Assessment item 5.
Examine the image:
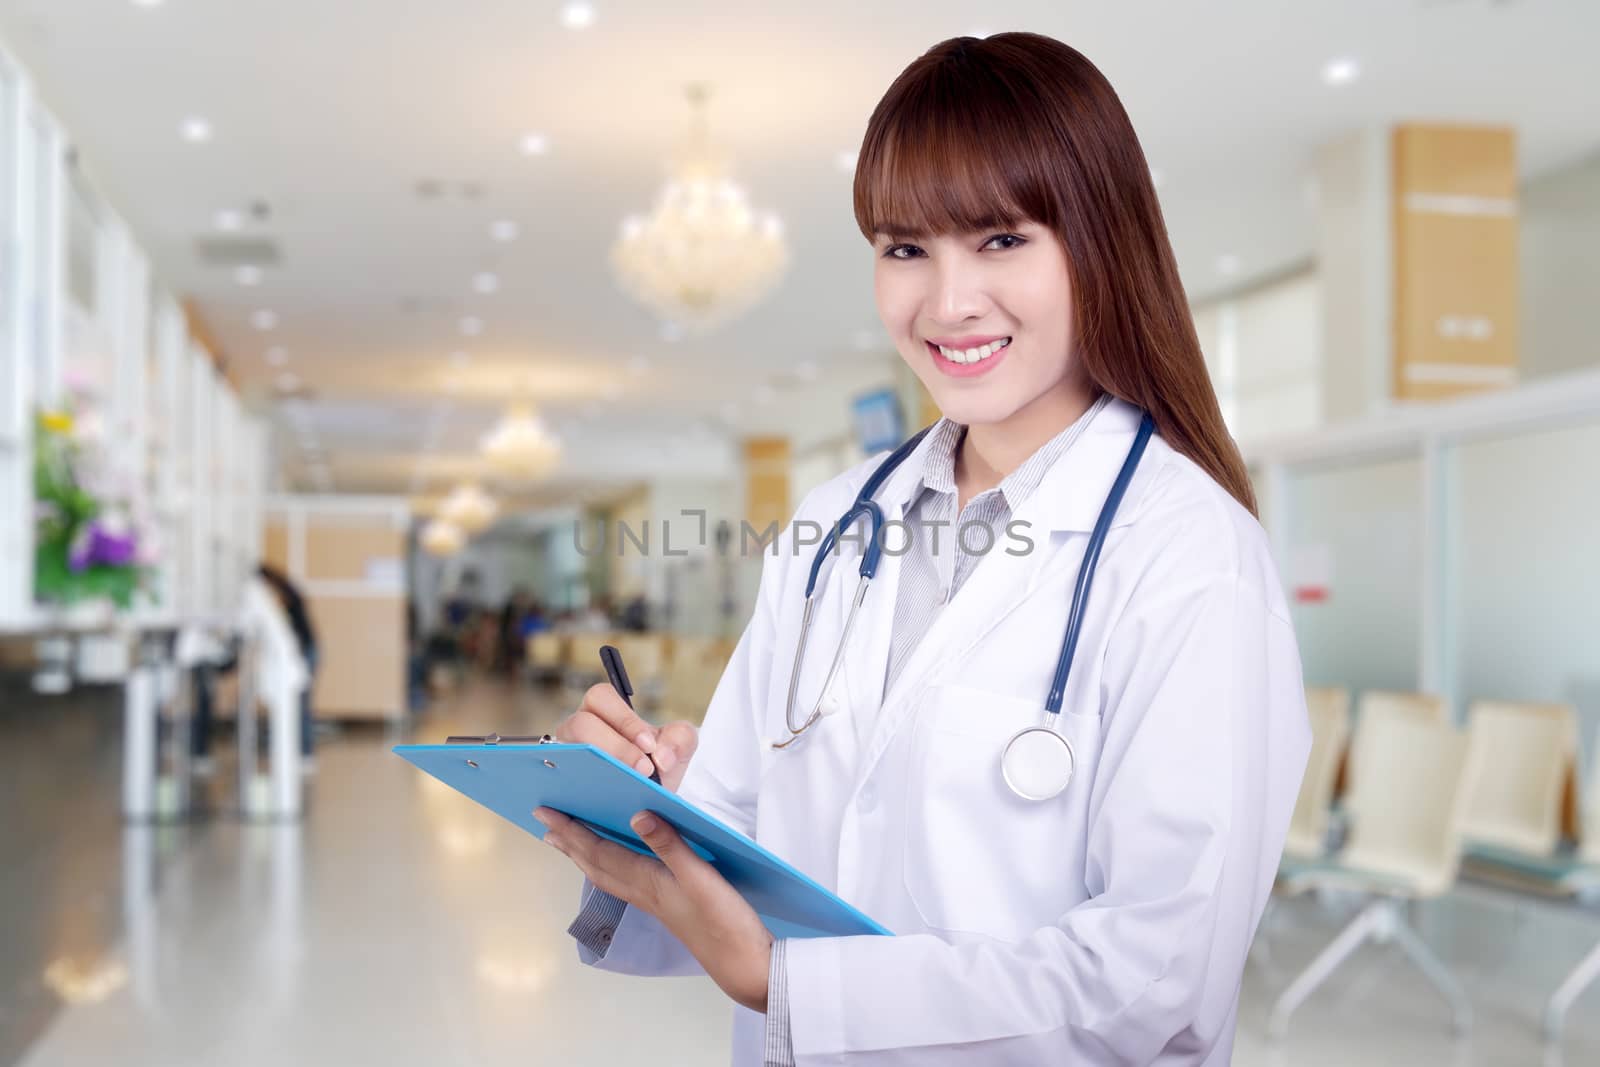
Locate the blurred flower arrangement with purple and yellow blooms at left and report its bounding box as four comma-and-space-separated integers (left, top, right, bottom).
34, 411, 155, 609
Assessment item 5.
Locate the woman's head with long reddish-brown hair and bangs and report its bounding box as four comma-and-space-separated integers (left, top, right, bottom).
854, 34, 1254, 512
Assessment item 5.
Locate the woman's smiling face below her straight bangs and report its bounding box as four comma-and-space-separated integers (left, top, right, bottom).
872, 221, 1075, 426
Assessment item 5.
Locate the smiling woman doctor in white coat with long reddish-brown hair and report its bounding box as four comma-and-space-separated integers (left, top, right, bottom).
538, 34, 1309, 1067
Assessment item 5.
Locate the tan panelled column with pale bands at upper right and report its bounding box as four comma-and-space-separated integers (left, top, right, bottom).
1392, 123, 1518, 400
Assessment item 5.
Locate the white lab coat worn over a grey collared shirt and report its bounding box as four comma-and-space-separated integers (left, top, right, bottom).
598, 402, 1310, 1067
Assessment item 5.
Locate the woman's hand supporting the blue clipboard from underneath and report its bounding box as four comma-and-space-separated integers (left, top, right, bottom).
533, 808, 773, 1013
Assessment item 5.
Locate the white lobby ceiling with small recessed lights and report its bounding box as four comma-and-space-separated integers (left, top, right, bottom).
0, 0, 1600, 491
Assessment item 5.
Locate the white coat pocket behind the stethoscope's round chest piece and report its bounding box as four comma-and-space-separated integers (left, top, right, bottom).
904, 685, 1099, 941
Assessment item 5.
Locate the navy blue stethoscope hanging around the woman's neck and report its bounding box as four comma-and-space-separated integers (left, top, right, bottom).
770, 413, 1155, 800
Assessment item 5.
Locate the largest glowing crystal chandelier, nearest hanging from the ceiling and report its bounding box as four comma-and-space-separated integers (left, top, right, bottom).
611, 83, 789, 331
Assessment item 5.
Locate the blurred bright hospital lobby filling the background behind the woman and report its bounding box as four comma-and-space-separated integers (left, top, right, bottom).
0, 0, 1600, 1067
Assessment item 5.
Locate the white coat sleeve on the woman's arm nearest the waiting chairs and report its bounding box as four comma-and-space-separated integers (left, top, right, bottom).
787, 573, 1309, 1067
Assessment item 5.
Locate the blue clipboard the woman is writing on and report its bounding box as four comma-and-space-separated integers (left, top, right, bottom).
394, 741, 890, 937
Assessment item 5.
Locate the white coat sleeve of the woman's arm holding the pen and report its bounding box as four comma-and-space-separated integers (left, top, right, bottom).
568, 515, 790, 976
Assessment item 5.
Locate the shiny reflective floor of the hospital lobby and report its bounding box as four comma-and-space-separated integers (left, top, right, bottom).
0, 683, 1600, 1067
